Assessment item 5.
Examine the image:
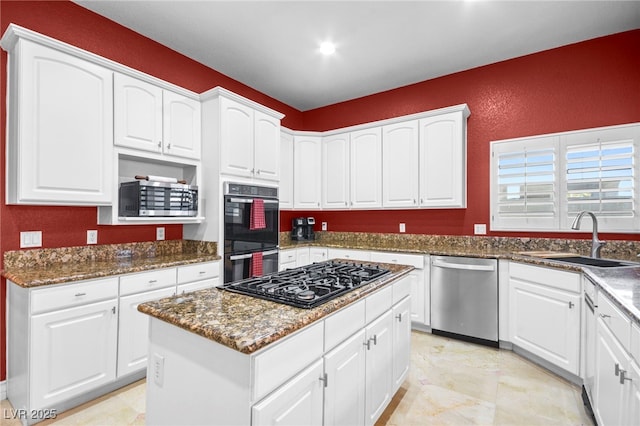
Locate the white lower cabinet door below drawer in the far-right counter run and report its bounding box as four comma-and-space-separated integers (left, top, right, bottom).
593, 317, 637, 425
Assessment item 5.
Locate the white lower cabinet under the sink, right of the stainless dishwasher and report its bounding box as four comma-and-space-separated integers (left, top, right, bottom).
509, 262, 582, 376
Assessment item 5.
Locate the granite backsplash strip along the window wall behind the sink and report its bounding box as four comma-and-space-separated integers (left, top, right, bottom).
280, 231, 640, 261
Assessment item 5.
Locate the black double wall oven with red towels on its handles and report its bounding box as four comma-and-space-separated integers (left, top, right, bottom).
224, 182, 280, 283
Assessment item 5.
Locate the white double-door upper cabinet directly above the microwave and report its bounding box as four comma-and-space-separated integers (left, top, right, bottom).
113, 73, 201, 159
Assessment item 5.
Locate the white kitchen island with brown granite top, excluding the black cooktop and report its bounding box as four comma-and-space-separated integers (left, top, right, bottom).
138, 264, 412, 425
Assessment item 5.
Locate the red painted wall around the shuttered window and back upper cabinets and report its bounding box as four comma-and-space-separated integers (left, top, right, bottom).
281, 30, 640, 243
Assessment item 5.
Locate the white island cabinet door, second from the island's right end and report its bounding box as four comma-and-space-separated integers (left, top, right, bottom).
365, 310, 393, 425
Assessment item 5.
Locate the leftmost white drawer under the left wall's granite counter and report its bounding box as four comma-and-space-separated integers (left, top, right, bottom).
31, 277, 118, 314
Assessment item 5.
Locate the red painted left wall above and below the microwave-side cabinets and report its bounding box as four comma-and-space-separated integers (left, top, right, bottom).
0, 1, 302, 381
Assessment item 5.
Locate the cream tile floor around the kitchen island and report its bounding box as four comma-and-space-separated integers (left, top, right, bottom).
1, 332, 593, 426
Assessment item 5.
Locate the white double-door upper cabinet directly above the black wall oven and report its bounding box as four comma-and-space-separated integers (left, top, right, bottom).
219, 96, 281, 181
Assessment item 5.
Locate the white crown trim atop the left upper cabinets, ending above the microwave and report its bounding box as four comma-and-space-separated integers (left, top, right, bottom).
0, 24, 200, 101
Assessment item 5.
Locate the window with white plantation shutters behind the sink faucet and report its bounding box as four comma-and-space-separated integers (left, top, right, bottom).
491, 125, 640, 232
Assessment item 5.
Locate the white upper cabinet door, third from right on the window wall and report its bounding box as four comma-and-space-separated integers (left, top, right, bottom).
349, 127, 382, 208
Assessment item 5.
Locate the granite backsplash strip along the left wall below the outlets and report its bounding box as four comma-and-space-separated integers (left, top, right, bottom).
4, 240, 218, 269
